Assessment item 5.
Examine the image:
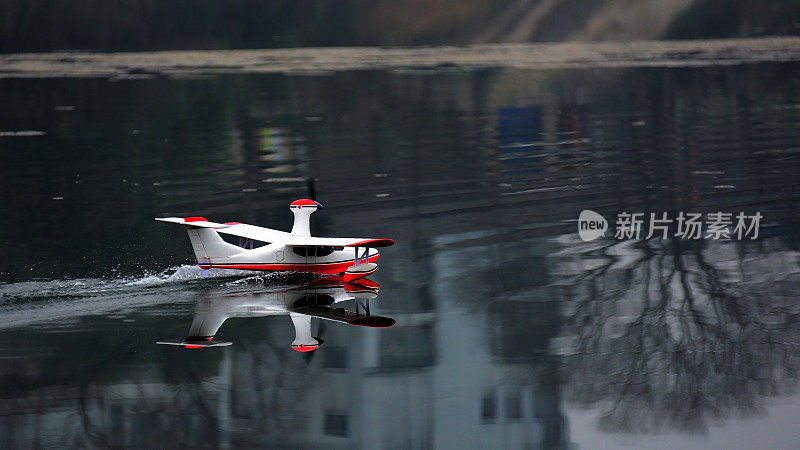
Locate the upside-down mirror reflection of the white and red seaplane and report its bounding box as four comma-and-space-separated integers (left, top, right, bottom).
158, 277, 395, 352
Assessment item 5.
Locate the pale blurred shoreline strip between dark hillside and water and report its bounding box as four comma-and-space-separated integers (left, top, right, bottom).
0, 37, 800, 79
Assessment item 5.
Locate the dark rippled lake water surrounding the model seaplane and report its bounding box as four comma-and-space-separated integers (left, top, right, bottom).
0, 64, 800, 448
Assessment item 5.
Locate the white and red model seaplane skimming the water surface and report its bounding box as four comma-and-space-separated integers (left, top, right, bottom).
156, 199, 394, 282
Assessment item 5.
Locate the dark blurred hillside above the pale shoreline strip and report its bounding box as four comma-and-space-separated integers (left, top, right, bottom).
0, 0, 800, 53
